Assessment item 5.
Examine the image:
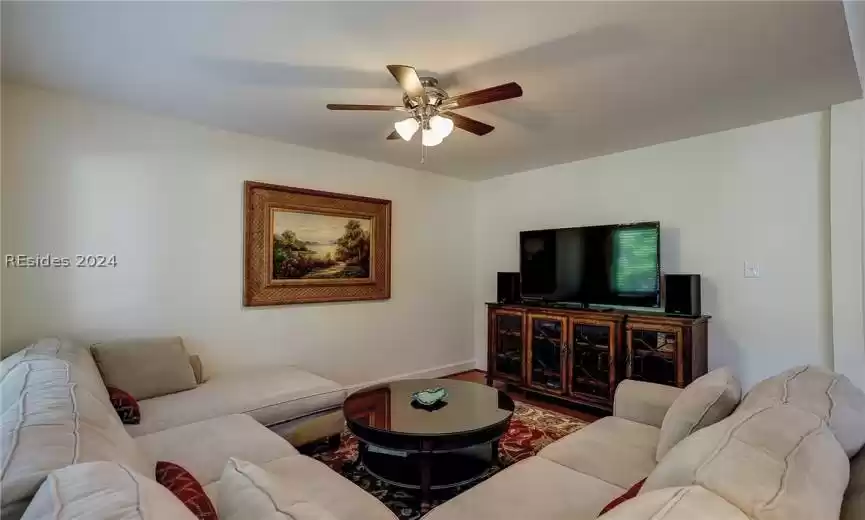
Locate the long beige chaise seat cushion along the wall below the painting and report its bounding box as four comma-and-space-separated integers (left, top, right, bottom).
126, 366, 345, 436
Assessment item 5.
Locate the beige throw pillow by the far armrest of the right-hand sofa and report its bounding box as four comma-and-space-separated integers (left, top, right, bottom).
655, 367, 742, 460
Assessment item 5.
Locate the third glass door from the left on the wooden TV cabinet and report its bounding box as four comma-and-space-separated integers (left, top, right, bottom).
568, 323, 615, 399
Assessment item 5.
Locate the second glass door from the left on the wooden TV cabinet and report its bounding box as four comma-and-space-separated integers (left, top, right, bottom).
529, 316, 567, 393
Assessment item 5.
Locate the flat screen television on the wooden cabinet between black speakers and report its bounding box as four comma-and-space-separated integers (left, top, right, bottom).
520, 222, 661, 307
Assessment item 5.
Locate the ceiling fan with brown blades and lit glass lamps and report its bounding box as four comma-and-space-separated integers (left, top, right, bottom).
327, 65, 523, 147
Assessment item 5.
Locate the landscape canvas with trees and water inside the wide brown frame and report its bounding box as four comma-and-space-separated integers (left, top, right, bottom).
271, 210, 371, 280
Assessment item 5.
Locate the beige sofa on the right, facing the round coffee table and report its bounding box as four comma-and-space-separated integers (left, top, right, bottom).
424, 367, 865, 520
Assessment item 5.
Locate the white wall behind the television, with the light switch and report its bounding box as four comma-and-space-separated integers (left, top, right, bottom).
474, 113, 832, 386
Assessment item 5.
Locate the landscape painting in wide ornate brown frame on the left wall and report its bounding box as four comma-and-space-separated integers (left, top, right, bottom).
243, 181, 391, 306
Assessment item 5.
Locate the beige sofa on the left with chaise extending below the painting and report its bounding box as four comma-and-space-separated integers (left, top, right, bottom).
0, 339, 394, 520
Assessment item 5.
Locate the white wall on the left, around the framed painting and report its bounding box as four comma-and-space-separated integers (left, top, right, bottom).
2, 85, 473, 383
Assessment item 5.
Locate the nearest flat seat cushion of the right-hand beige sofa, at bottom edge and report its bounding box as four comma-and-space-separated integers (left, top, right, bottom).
424, 457, 625, 520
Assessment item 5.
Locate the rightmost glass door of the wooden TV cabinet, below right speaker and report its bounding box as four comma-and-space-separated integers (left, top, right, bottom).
625, 323, 684, 387
